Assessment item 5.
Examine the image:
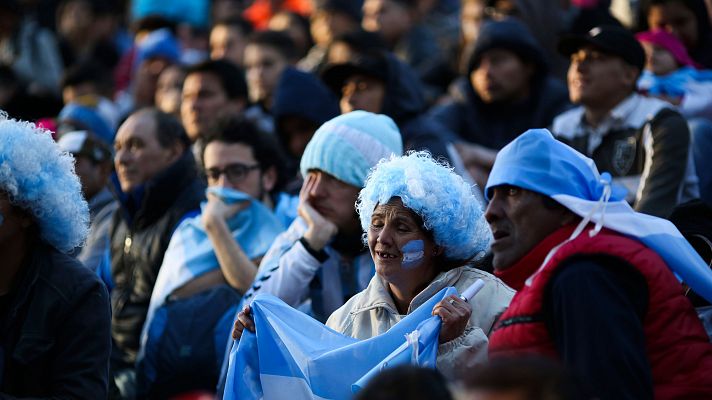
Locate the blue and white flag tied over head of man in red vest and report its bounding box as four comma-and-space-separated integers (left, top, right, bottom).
485, 129, 712, 301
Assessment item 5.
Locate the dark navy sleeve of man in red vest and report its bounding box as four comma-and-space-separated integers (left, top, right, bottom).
544, 257, 653, 400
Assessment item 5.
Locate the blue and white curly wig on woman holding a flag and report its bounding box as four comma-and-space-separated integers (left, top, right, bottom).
356, 151, 491, 261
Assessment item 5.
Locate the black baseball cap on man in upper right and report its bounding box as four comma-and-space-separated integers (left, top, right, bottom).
558, 26, 645, 70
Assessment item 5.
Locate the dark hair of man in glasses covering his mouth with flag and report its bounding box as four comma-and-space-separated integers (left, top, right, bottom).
200, 117, 287, 193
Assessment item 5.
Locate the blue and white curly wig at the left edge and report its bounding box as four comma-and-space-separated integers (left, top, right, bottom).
0, 112, 89, 252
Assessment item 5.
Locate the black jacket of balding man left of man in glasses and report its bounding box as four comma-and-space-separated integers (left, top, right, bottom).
109, 151, 205, 368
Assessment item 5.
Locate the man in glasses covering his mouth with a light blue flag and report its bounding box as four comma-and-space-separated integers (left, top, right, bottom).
137, 119, 286, 398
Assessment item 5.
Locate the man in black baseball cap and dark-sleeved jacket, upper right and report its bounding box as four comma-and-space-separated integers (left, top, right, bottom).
552, 27, 699, 217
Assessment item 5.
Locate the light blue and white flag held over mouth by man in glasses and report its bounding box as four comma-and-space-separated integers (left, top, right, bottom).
142, 187, 284, 358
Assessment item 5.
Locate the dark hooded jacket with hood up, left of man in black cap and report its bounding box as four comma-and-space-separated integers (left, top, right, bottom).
430, 20, 570, 150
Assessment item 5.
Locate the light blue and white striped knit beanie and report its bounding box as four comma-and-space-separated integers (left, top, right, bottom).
300, 111, 403, 188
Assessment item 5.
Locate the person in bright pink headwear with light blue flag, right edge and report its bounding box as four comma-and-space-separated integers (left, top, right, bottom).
635, 30, 712, 119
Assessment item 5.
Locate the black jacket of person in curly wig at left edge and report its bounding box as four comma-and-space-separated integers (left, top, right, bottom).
0, 241, 111, 399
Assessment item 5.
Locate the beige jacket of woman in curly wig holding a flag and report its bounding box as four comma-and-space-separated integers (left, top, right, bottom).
326, 266, 515, 379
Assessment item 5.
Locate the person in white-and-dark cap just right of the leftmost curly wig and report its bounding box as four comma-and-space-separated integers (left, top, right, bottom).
57, 131, 118, 271
